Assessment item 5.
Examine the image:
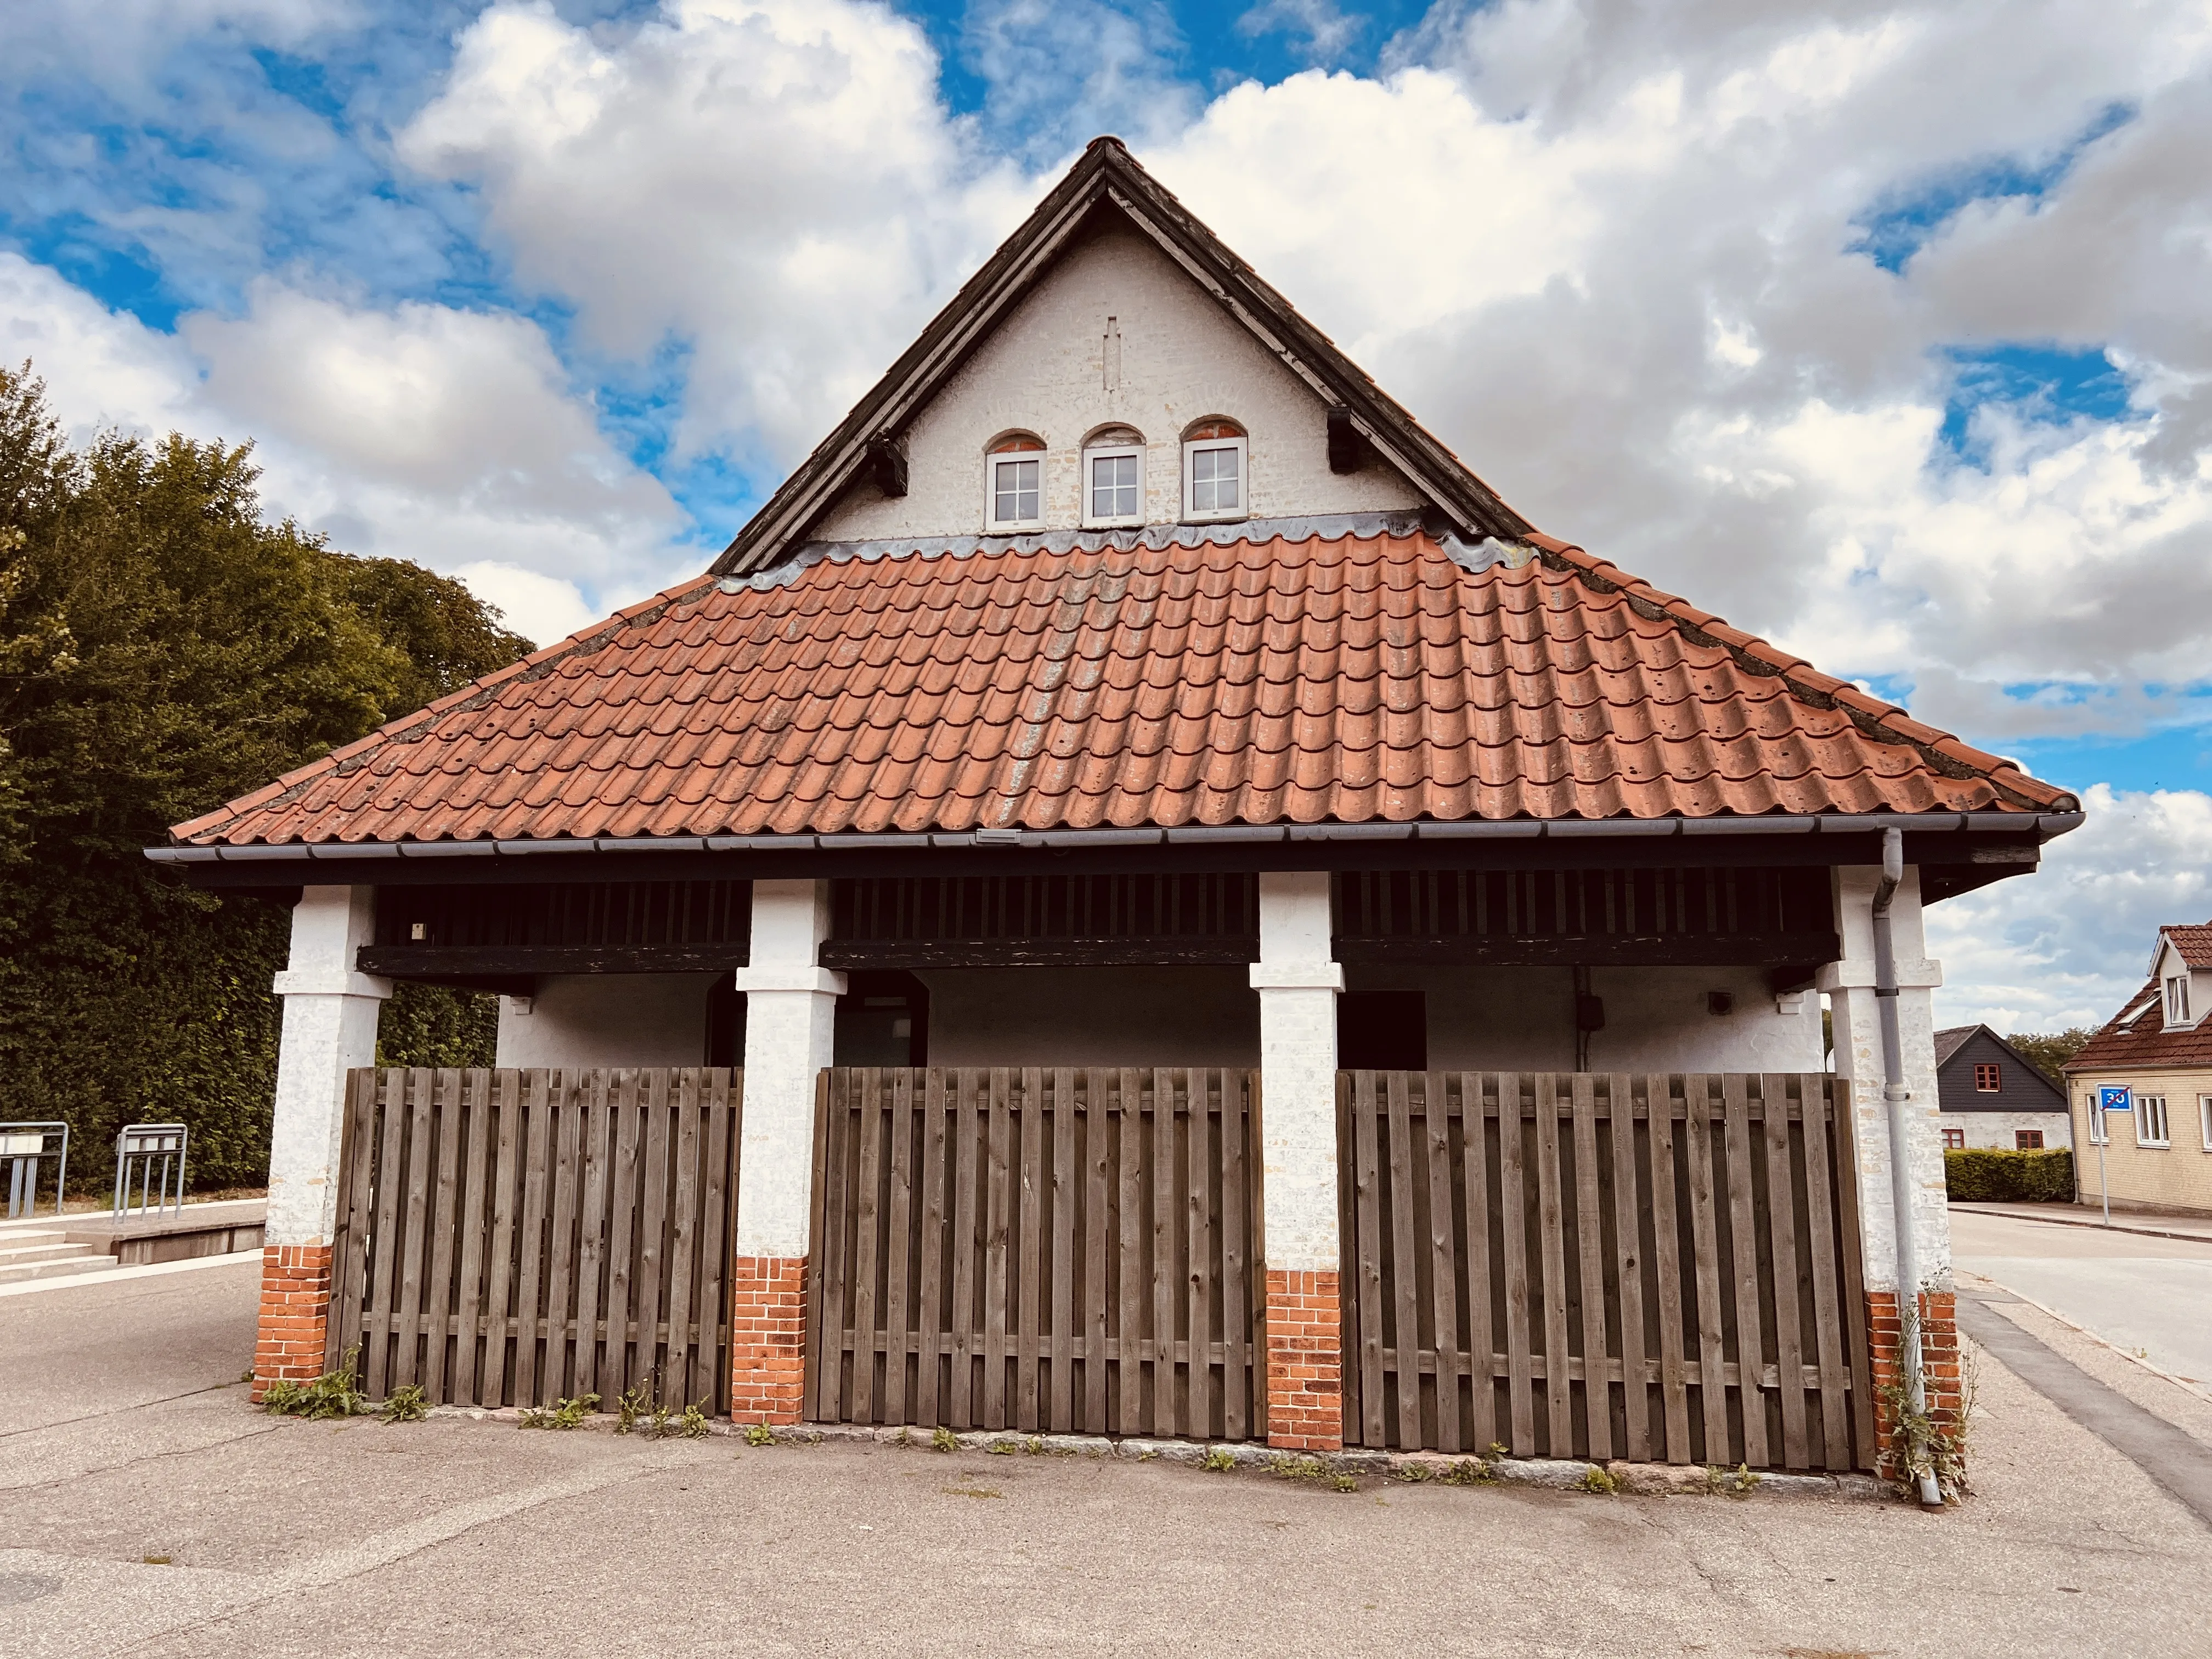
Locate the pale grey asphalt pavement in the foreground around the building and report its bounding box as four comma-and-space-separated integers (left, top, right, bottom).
0, 1265, 2212, 1659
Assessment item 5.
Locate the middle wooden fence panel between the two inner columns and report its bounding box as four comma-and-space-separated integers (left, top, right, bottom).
808, 1068, 1267, 1440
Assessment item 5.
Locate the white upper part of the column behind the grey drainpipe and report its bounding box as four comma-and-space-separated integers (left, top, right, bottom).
1816, 865, 1951, 1292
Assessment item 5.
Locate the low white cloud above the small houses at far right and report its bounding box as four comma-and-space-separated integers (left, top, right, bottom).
1927, 783, 2212, 1031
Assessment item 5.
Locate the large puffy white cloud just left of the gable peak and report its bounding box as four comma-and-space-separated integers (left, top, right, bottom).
396, 0, 1037, 467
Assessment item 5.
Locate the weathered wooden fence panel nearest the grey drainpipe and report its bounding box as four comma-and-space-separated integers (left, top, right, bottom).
1338, 1070, 1874, 1469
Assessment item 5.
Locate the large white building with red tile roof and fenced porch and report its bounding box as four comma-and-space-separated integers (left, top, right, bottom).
150, 139, 2079, 1466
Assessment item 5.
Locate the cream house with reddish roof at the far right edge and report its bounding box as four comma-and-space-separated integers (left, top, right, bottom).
2066, 922, 2212, 1215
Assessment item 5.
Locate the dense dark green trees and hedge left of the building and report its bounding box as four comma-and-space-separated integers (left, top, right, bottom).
0, 365, 529, 1186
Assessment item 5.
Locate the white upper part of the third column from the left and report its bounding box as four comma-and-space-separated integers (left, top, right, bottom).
1252, 872, 1345, 1272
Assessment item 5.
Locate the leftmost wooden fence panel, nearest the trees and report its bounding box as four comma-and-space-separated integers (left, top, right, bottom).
330, 1068, 743, 1411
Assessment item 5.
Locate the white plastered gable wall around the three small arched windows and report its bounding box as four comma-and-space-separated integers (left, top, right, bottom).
814, 230, 1423, 542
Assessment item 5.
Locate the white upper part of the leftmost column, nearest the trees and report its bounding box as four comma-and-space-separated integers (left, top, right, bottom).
268, 887, 392, 1245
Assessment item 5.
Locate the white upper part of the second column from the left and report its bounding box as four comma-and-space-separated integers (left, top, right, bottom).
735, 881, 845, 1259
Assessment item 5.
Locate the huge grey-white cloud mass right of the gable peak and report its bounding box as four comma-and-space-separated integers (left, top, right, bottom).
1146, 0, 2212, 739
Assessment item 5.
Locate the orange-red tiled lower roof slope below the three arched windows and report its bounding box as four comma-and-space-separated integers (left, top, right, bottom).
175, 533, 2075, 845
